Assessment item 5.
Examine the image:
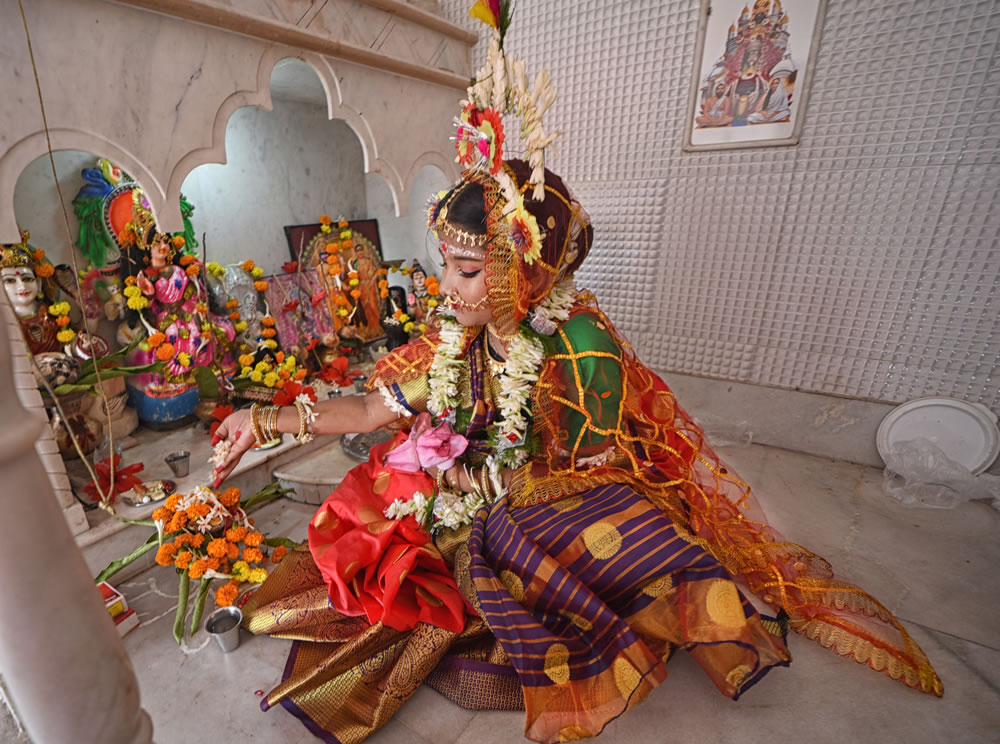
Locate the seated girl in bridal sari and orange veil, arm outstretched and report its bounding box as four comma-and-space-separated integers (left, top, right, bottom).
209, 160, 941, 742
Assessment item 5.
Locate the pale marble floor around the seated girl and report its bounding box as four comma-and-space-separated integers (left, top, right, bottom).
109, 445, 1000, 744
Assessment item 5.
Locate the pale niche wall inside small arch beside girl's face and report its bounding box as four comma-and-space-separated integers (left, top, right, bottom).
365, 165, 450, 264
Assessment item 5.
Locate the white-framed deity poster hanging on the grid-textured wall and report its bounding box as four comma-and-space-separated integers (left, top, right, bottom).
684, 0, 826, 150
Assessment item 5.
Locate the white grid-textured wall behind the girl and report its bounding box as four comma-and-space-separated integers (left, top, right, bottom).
443, 0, 1000, 410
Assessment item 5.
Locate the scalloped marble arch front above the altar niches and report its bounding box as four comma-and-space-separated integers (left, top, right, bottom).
0, 0, 473, 241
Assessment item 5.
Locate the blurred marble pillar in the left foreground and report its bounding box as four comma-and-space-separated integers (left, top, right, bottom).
0, 312, 153, 744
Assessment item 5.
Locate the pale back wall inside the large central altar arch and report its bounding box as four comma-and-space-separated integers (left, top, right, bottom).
181, 100, 368, 273
